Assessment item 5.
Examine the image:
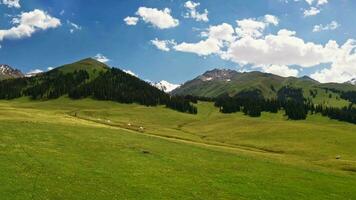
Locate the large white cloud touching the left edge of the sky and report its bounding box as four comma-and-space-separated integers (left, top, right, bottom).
0, 9, 61, 41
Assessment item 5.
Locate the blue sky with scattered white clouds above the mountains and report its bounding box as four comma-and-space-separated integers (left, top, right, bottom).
0, 0, 356, 83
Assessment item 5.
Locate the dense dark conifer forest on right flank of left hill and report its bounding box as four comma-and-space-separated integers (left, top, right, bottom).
69, 68, 197, 114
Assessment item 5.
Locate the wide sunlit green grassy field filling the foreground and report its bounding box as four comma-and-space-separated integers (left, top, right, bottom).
0, 98, 356, 200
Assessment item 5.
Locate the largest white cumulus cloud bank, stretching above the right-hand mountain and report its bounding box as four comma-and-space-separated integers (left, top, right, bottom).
160, 12, 356, 82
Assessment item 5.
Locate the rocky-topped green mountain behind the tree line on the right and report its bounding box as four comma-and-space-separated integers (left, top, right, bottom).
172, 69, 356, 98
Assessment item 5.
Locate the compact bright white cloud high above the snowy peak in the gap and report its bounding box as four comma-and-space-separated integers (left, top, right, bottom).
136, 7, 179, 29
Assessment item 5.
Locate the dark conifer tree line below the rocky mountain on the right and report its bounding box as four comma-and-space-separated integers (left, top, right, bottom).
215, 86, 356, 124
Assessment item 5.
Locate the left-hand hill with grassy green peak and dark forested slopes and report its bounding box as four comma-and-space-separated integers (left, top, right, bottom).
0, 58, 197, 114
